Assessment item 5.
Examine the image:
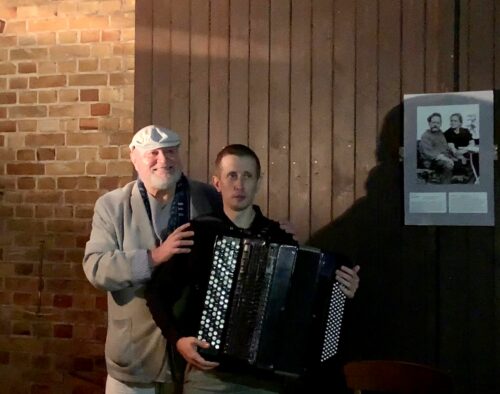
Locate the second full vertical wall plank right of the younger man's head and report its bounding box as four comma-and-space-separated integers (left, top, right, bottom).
290, 0, 311, 241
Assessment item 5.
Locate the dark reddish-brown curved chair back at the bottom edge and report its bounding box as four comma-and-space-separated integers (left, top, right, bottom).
344, 360, 452, 394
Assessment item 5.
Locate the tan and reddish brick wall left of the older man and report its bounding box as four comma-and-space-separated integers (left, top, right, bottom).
0, 0, 135, 394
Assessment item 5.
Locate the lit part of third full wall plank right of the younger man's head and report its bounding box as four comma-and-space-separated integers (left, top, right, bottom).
310, 0, 333, 232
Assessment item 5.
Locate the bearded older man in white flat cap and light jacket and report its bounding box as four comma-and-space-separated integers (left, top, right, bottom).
83, 126, 221, 394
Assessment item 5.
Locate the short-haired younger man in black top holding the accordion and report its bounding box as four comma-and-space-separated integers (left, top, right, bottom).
146, 144, 359, 393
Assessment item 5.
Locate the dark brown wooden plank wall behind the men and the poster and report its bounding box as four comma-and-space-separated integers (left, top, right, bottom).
135, 0, 500, 394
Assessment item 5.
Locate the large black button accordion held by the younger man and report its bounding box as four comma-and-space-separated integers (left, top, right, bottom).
198, 236, 345, 376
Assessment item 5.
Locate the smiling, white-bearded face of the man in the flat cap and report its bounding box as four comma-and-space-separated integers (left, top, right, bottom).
130, 147, 182, 194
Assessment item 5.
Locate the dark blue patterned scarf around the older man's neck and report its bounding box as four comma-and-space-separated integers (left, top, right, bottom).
137, 174, 190, 244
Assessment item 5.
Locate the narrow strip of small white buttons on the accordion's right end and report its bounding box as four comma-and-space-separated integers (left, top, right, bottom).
321, 282, 345, 362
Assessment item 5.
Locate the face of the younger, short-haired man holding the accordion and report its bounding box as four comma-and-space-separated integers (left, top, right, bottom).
212, 155, 260, 212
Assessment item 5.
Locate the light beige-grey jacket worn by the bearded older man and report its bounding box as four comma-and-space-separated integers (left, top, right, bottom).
83, 181, 220, 383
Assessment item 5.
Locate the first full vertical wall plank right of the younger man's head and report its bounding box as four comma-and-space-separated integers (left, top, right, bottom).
268, 0, 290, 219
